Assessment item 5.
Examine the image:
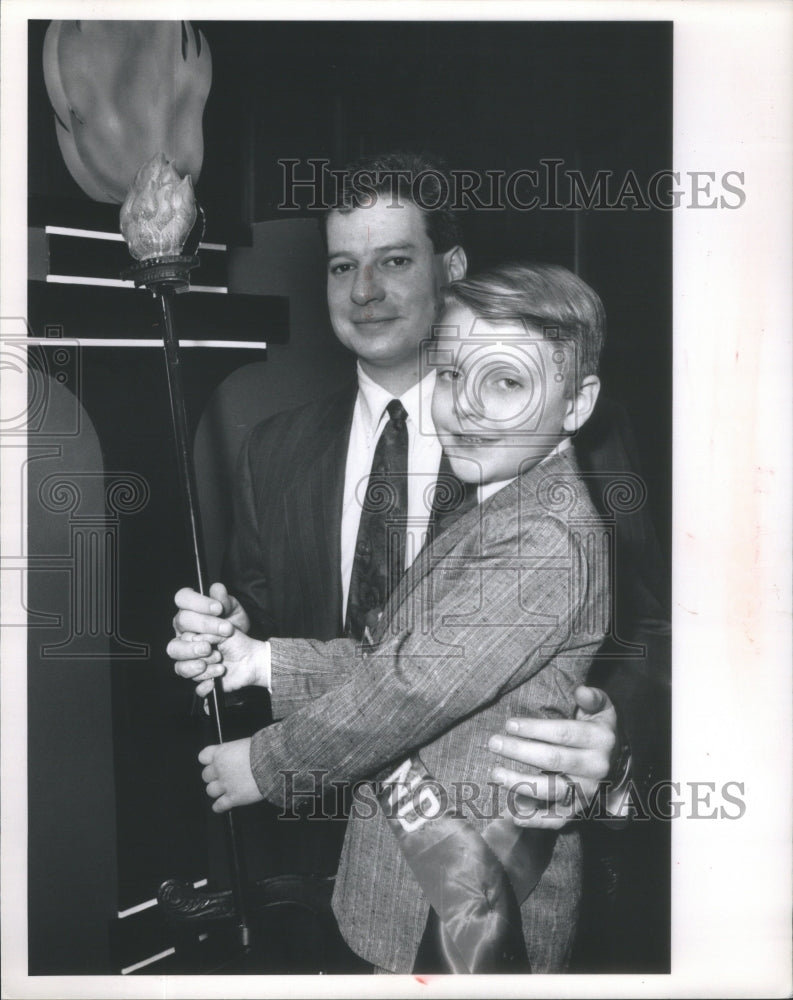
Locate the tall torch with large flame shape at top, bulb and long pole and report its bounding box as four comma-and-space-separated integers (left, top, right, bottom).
42, 19, 255, 950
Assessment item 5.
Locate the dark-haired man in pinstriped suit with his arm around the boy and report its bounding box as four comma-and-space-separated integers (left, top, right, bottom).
168, 155, 664, 968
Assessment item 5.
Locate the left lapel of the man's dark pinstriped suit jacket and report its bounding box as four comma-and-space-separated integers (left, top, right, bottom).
283, 387, 357, 635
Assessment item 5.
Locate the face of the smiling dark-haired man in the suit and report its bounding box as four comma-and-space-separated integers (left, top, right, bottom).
327, 197, 449, 381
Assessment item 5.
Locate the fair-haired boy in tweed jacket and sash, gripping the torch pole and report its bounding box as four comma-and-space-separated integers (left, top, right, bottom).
178, 264, 609, 972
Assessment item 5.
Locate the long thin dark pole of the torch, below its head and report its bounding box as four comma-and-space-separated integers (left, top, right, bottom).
155, 287, 250, 948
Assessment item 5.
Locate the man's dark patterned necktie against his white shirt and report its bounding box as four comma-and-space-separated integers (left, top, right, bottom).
345, 399, 408, 639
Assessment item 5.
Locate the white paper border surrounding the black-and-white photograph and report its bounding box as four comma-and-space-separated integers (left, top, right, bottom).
0, 0, 793, 998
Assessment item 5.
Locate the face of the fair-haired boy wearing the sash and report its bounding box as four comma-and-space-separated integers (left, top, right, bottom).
432, 305, 575, 483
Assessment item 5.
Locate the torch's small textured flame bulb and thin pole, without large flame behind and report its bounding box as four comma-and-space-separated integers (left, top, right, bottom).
121, 153, 250, 948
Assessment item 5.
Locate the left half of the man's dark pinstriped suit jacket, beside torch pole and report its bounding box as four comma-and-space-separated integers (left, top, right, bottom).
225, 385, 357, 640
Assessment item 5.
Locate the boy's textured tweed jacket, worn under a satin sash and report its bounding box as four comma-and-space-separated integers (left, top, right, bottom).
251, 450, 609, 973
